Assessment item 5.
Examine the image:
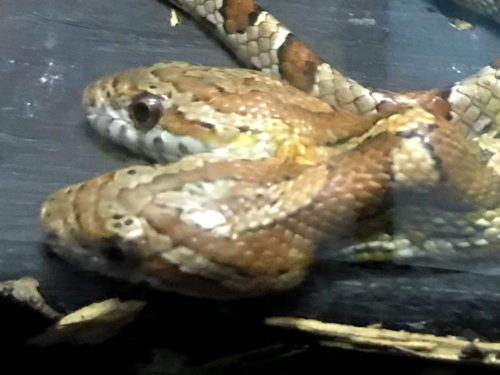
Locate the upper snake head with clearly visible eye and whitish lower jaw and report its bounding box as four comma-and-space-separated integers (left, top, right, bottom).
83, 62, 294, 162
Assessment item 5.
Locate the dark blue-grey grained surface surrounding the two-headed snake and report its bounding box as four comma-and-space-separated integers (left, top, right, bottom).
0, 0, 500, 374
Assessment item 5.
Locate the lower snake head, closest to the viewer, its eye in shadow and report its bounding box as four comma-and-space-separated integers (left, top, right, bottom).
40, 160, 320, 299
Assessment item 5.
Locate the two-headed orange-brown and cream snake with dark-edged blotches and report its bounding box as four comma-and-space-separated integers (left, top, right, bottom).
40, 0, 500, 299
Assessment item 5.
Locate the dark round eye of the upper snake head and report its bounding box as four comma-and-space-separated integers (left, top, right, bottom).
128, 94, 164, 130
